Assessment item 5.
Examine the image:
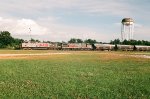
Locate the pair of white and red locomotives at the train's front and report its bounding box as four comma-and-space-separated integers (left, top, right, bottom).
21, 42, 92, 50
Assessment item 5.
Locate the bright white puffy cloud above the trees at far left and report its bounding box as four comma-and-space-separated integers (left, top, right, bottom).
0, 17, 47, 35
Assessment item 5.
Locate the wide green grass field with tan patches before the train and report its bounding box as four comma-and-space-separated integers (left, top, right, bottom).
0, 50, 150, 99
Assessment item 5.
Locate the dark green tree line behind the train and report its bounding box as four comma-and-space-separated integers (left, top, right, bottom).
0, 31, 150, 49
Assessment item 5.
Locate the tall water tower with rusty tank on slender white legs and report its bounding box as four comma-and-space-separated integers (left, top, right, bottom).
121, 18, 134, 41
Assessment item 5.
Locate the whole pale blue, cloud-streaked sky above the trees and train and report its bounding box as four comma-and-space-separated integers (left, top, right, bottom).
0, 0, 150, 42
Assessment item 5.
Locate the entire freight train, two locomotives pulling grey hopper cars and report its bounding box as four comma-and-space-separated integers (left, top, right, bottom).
21, 42, 150, 51
